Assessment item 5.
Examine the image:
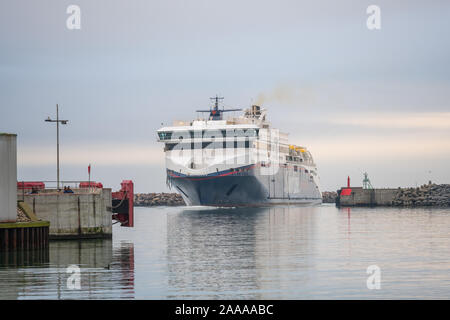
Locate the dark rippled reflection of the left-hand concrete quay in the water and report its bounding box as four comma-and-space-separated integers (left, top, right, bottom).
0, 239, 134, 299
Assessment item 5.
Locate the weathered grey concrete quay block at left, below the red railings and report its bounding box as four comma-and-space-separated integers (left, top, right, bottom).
19, 188, 112, 239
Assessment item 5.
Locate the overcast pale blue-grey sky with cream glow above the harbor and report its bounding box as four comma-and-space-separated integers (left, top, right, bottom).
0, 0, 450, 192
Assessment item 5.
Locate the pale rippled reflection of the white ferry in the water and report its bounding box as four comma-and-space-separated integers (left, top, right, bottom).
167, 207, 316, 299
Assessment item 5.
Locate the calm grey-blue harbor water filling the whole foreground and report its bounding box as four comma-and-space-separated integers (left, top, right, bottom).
0, 205, 450, 299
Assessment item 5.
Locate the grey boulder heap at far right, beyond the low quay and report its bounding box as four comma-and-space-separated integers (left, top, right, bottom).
392, 183, 450, 207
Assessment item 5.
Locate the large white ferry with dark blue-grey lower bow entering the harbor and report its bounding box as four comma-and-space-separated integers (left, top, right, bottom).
157, 96, 322, 207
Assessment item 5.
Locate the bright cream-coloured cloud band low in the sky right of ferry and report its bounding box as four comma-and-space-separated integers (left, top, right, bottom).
290, 112, 450, 168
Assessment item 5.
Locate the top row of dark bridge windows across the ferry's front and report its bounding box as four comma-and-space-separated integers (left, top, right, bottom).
158, 129, 259, 140
